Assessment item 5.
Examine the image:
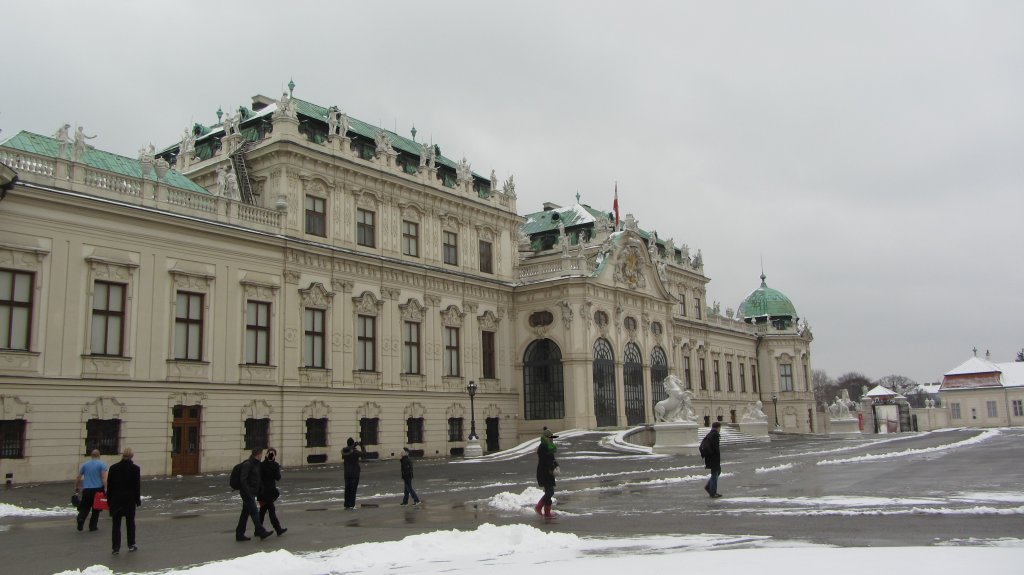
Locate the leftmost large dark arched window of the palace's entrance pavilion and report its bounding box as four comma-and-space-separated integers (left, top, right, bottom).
522, 340, 565, 419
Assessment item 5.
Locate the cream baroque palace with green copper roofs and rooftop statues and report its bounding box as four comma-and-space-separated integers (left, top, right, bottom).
0, 83, 816, 482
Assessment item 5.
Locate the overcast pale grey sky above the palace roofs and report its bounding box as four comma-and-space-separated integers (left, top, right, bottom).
0, 0, 1024, 383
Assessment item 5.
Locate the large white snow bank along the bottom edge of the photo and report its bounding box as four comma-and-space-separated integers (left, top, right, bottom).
49, 524, 1024, 575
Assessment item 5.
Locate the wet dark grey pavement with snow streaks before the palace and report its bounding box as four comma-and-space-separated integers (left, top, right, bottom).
0, 429, 1024, 573
